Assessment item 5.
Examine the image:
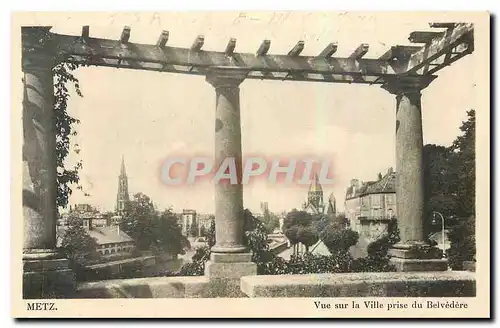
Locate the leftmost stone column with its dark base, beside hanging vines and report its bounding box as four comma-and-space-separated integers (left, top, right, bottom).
22, 37, 74, 298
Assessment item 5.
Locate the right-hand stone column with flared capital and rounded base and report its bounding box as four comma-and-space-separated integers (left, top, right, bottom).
383, 77, 447, 271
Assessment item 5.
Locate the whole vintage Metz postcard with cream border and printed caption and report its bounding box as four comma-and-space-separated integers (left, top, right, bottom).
11, 11, 491, 318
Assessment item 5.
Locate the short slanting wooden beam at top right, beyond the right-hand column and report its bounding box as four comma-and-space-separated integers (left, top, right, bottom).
405, 23, 474, 74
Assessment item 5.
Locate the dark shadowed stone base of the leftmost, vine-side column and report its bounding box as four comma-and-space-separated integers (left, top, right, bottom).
23, 250, 75, 299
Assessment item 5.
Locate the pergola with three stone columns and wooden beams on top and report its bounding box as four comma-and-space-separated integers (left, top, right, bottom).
22, 23, 474, 298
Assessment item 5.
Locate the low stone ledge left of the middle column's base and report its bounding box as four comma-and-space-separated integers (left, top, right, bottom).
74, 276, 209, 298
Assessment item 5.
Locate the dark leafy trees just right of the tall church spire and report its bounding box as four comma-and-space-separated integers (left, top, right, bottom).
120, 193, 189, 254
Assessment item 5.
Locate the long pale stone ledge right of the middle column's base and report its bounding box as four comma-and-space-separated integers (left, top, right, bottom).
241, 271, 476, 297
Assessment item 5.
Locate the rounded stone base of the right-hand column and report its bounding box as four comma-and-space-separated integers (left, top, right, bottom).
388, 242, 448, 272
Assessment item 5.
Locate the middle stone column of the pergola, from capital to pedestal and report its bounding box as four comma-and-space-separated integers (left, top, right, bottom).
205, 67, 257, 297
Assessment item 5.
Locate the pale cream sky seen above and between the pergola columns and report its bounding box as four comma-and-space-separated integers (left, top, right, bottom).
47, 12, 477, 213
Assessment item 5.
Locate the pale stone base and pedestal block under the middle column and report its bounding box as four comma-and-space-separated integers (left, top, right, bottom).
205, 253, 257, 297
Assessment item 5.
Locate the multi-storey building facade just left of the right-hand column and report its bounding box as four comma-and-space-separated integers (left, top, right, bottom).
345, 168, 397, 243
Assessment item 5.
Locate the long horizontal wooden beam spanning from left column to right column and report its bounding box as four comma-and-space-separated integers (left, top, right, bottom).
44, 34, 395, 81
